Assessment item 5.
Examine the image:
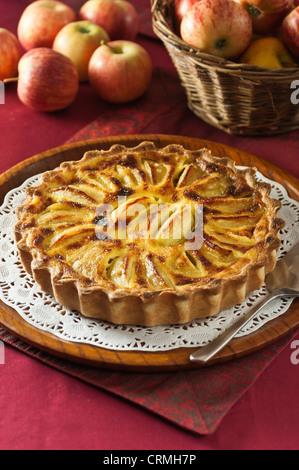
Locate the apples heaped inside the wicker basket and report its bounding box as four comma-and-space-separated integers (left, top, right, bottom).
174, 0, 299, 69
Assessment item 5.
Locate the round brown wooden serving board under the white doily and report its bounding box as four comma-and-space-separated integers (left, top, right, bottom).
0, 135, 299, 372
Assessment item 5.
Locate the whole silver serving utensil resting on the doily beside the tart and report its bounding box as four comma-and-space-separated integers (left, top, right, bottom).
190, 243, 299, 363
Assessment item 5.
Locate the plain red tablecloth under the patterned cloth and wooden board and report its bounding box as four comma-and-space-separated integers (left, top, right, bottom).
0, 0, 299, 450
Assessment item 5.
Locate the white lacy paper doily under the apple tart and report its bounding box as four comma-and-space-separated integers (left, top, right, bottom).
0, 167, 299, 351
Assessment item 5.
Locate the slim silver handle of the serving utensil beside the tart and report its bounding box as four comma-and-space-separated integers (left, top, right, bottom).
190, 293, 278, 363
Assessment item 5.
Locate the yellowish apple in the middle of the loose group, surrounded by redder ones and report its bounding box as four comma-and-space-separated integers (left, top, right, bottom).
53, 21, 110, 82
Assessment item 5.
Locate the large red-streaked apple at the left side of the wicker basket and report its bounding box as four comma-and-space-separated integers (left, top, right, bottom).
181, 0, 252, 59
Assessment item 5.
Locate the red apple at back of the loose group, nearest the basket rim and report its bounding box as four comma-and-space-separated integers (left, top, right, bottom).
79, 0, 138, 41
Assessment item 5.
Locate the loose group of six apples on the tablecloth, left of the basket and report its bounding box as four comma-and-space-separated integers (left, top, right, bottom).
0, 0, 152, 112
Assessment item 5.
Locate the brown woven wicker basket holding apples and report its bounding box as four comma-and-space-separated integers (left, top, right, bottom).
152, 0, 299, 136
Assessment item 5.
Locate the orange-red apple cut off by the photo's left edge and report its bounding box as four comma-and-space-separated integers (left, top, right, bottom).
0, 28, 21, 80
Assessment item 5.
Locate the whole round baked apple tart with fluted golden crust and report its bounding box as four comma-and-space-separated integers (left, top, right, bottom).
15, 142, 284, 326
